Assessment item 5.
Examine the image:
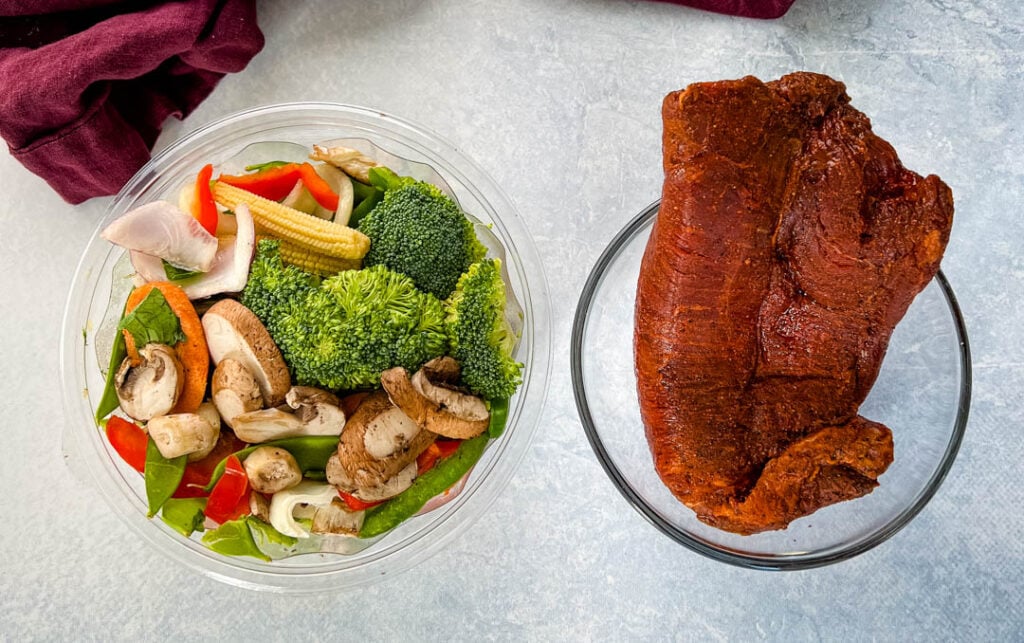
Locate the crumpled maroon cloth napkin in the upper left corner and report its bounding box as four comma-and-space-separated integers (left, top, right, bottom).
0, 0, 263, 203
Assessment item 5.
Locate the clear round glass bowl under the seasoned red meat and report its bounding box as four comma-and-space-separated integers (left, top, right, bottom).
571, 202, 971, 569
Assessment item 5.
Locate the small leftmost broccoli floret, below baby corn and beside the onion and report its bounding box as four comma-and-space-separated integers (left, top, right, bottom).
241, 239, 319, 338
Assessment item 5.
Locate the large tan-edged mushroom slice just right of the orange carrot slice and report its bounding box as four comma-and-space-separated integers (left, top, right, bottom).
203, 299, 291, 406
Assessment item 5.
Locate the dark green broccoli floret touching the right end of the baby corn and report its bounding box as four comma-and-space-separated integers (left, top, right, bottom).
358, 168, 486, 299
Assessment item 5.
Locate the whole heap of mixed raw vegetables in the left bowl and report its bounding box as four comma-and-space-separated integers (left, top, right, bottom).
96, 140, 522, 560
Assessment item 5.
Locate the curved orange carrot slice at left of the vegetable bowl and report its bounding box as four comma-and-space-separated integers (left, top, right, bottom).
125, 282, 210, 413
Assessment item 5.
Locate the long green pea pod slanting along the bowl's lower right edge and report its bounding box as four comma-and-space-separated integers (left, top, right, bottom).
359, 434, 488, 538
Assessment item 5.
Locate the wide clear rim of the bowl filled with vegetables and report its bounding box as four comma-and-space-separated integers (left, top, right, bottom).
58, 101, 552, 594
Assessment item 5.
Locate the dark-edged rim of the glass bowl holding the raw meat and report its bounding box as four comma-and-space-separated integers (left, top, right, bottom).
569, 199, 972, 571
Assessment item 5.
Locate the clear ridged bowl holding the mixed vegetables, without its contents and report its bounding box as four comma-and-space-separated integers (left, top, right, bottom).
60, 103, 551, 592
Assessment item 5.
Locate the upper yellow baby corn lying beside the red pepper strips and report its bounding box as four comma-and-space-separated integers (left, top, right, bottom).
213, 181, 370, 262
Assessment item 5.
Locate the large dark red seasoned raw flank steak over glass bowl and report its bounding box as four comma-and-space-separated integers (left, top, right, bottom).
634, 73, 953, 533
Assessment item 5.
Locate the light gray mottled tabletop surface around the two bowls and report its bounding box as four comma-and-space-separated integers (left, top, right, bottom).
0, 0, 1024, 641
